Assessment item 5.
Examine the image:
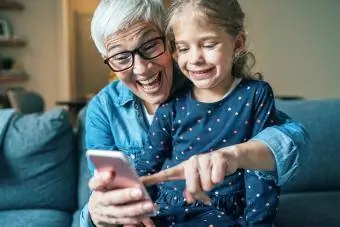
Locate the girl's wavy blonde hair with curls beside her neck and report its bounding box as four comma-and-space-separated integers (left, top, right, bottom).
166, 0, 262, 79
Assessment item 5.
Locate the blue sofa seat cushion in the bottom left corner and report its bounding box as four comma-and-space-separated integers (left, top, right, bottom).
0, 210, 72, 227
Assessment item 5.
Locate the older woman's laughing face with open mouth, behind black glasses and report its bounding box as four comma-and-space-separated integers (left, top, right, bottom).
105, 22, 173, 104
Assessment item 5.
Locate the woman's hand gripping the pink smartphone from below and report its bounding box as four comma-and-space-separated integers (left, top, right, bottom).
88, 169, 155, 227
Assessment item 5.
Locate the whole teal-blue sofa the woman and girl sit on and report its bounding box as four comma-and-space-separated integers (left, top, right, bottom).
0, 100, 340, 227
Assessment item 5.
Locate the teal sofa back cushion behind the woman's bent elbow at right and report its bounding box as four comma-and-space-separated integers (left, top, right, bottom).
276, 99, 340, 192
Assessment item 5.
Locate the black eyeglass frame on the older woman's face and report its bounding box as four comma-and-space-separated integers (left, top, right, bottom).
104, 36, 166, 72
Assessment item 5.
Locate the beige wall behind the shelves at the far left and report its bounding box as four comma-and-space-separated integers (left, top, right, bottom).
1, 0, 61, 108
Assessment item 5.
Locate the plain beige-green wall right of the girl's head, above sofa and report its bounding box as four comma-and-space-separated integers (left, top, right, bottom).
240, 0, 340, 99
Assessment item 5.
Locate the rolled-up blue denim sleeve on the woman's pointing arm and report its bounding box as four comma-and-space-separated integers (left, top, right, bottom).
252, 111, 311, 186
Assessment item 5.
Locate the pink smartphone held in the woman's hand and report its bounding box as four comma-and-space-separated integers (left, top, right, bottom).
86, 150, 151, 201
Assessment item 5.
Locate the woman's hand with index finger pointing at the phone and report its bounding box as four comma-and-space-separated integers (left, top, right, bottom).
140, 146, 240, 205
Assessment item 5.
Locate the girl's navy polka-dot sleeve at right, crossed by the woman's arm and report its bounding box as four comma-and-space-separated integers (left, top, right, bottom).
244, 83, 280, 226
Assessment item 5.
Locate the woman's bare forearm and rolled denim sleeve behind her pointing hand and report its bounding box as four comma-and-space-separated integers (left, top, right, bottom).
247, 111, 310, 186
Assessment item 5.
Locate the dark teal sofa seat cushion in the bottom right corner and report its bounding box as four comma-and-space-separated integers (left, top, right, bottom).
275, 192, 340, 227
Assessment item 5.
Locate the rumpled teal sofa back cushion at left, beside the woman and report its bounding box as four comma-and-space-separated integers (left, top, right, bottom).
0, 109, 78, 211
